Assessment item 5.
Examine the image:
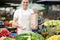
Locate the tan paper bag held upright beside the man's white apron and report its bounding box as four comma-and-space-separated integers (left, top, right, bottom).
30, 14, 38, 30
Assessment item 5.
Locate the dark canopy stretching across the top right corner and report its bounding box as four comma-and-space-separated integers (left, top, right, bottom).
36, 0, 60, 5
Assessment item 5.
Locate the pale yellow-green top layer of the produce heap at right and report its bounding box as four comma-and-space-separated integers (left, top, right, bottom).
43, 20, 60, 29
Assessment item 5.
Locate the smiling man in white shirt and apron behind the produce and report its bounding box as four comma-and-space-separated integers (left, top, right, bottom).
13, 0, 34, 34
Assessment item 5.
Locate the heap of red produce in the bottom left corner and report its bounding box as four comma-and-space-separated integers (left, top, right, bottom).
0, 28, 15, 40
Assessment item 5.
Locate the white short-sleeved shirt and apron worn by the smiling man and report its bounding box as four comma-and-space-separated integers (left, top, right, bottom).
14, 8, 34, 34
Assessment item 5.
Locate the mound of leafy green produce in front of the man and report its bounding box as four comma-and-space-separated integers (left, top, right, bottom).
16, 33, 44, 40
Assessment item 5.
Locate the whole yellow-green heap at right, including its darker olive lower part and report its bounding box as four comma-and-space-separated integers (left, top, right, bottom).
43, 20, 60, 36
